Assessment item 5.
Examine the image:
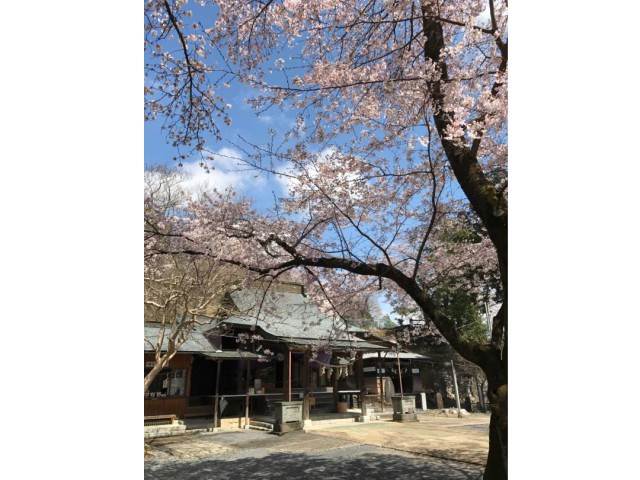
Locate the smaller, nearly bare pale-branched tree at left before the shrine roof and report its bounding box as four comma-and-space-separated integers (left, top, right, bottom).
144, 167, 248, 392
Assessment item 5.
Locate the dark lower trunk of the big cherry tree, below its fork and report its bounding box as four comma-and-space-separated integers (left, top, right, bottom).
483, 382, 508, 480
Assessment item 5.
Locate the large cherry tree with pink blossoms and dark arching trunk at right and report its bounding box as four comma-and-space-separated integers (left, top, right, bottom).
145, 0, 508, 479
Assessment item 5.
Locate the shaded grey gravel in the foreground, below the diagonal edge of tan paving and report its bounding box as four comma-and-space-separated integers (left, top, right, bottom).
144, 431, 483, 480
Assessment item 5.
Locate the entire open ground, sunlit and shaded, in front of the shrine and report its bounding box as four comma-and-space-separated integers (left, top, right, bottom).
145, 414, 489, 480
